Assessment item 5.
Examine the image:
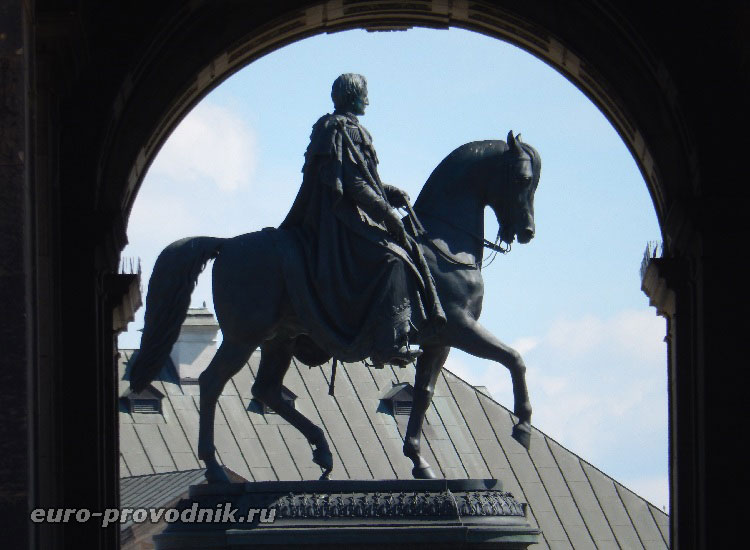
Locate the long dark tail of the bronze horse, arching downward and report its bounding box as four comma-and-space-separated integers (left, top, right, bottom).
130, 237, 226, 392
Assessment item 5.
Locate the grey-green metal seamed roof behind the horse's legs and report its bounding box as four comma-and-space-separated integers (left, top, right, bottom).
120, 350, 669, 550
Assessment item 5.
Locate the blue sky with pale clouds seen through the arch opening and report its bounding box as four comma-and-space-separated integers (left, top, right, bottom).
120, 29, 668, 507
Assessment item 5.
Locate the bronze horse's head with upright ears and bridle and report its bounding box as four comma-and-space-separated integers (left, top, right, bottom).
488, 130, 541, 244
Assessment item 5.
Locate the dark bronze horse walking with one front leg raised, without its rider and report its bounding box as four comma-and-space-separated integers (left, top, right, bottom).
130, 132, 541, 482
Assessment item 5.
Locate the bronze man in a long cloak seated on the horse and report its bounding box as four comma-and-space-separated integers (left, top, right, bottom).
281, 74, 446, 365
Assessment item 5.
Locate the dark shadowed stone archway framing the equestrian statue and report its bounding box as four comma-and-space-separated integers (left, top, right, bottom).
8, 0, 750, 547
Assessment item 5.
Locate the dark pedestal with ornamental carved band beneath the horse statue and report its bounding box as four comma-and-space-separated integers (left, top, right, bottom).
154, 479, 540, 550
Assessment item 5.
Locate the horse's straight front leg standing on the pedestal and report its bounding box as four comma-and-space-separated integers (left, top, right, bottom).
404, 347, 450, 479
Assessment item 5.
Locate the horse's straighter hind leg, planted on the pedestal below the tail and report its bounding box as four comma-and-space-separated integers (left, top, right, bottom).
198, 339, 255, 483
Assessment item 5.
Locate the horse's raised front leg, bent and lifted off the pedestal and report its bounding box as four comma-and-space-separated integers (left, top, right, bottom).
446, 316, 531, 449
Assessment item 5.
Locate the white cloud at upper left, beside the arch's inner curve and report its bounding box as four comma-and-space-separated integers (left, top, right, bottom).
149, 101, 257, 192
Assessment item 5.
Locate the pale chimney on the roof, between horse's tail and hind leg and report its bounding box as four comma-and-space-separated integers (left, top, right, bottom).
169, 302, 219, 384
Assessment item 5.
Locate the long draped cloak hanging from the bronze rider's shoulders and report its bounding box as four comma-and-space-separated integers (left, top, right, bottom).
279, 113, 426, 361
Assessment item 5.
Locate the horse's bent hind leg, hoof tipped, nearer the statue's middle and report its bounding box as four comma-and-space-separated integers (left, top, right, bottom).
252, 340, 333, 479
